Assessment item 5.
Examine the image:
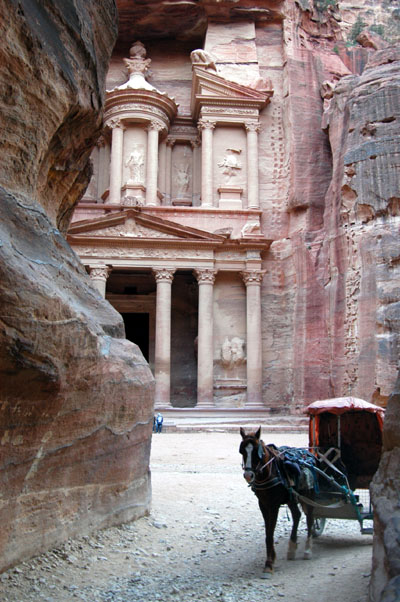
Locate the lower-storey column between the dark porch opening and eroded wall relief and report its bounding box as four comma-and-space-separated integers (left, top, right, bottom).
195, 269, 217, 408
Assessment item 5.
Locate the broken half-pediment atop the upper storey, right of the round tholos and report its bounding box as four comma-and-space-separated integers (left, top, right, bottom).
191, 66, 273, 119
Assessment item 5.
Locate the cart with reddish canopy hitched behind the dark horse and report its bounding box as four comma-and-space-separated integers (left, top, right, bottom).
306, 397, 384, 537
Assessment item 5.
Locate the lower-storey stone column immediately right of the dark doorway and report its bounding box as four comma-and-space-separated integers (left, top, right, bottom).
153, 268, 175, 407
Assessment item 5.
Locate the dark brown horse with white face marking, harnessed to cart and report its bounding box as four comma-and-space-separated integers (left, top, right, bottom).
239, 426, 314, 578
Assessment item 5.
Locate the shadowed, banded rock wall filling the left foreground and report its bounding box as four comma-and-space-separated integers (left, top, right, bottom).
0, 0, 153, 569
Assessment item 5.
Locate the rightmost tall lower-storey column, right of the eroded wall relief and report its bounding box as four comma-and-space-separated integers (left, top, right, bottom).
241, 270, 265, 406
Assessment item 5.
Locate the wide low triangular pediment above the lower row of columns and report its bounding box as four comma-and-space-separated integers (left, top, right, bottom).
68, 208, 225, 243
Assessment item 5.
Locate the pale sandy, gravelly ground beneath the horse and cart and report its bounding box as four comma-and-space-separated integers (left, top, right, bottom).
0, 432, 372, 602
